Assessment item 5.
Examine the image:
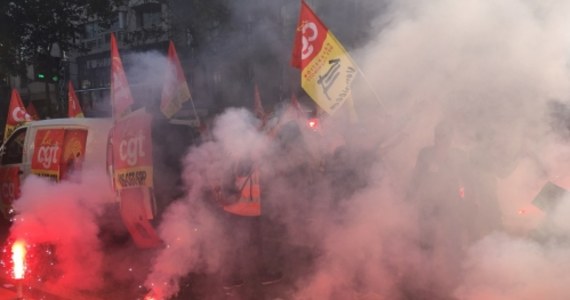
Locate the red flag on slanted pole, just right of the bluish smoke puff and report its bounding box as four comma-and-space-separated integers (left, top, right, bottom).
160, 41, 192, 118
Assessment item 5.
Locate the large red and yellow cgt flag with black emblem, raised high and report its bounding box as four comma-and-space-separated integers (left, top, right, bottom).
291, 1, 358, 114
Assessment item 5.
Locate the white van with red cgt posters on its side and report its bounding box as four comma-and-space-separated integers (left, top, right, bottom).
0, 118, 113, 213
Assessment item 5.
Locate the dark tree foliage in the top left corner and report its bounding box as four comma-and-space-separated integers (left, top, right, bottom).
0, 0, 124, 74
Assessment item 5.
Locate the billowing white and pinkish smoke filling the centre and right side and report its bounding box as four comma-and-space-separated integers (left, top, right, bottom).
142, 0, 570, 299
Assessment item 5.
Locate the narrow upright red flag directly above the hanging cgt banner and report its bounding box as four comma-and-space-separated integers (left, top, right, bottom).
111, 33, 134, 120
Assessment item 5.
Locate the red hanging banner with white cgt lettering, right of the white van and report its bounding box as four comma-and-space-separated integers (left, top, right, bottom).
111, 109, 153, 190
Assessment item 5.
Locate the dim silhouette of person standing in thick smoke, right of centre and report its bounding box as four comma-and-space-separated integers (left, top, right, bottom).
409, 122, 471, 299
